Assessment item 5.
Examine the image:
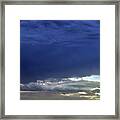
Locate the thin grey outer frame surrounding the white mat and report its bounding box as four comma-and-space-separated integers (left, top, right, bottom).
0, 0, 120, 120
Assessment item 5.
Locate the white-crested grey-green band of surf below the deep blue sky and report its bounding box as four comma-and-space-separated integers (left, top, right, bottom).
21, 75, 100, 92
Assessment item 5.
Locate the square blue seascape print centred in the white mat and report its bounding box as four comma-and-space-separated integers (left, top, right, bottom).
20, 20, 100, 100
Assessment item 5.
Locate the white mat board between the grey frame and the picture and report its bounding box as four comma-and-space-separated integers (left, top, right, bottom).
5, 5, 115, 115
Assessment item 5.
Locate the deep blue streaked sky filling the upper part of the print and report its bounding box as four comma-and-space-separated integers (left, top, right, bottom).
20, 20, 100, 83
